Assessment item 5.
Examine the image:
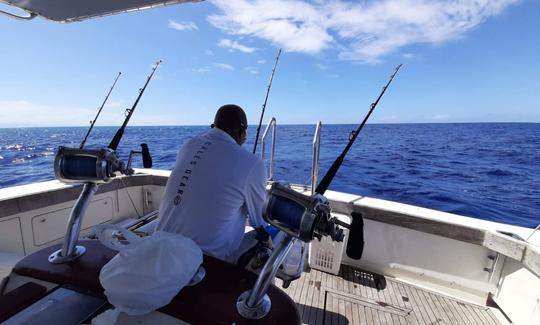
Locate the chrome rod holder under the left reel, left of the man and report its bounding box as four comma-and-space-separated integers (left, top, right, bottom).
49, 183, 98, 264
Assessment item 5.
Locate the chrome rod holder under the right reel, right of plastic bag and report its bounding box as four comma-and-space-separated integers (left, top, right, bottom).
236, 234, 296, 319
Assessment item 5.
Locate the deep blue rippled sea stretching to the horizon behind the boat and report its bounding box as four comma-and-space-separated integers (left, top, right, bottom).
0, 123, 540, 227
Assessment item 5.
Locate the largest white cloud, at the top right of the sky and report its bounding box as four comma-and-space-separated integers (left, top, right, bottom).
208, 0, 519, 63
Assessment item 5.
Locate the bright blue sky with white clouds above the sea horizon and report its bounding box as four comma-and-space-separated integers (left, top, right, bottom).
0, 0, 540, 127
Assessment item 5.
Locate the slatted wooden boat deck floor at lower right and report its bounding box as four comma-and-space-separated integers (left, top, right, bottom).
276, 265, 501, 325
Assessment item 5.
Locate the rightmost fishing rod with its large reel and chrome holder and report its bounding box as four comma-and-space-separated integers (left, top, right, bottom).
236, 64, 401, 294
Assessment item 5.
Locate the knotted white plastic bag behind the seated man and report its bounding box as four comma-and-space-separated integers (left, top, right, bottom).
94, 225, 202, 315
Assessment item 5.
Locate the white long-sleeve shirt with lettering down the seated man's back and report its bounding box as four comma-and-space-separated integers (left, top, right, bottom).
157, 128, 266, 260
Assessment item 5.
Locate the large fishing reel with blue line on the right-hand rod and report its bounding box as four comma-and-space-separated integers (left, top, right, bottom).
264, 183, 349, 243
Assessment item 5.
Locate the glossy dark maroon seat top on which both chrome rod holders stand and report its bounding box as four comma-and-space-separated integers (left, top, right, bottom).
13, 240, 300, 324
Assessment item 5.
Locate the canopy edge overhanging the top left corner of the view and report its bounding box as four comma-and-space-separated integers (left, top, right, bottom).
0, 0, 202, 23
